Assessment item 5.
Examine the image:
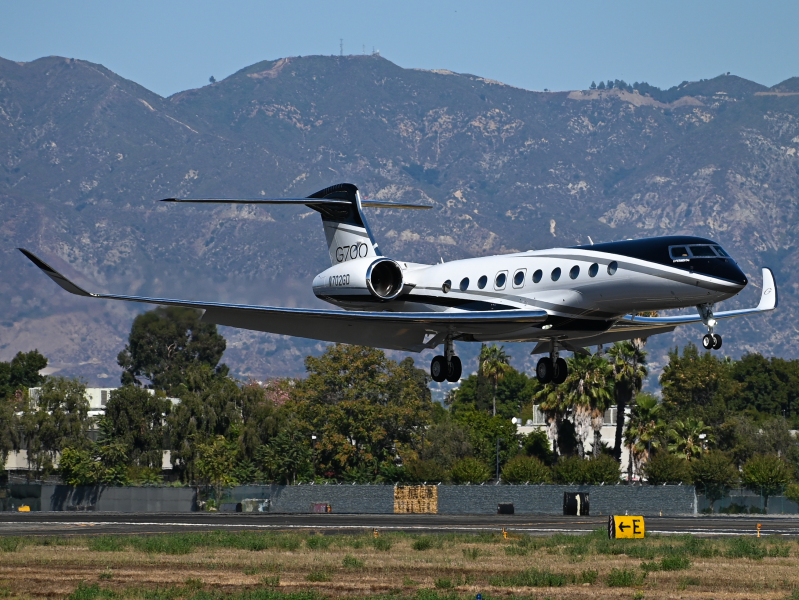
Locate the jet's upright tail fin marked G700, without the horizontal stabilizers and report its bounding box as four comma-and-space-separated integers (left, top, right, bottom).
308, 183, 382, 265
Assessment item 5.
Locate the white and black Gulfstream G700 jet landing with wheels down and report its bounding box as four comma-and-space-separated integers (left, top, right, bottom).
21, 183, 777, 383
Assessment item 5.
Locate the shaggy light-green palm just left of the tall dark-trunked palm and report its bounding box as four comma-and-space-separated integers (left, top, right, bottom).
563, 354, 614, 458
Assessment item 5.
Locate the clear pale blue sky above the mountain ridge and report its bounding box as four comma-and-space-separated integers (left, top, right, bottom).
0, 0, 799, 96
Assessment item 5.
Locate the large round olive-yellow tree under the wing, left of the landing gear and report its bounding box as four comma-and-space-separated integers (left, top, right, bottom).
287, 344, 432, 481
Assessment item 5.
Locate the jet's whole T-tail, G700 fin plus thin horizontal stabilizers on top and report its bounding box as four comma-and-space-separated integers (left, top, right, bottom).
162, 183, 432, 265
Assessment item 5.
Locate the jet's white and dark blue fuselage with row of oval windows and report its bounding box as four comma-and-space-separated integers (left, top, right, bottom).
314, 236, 747, 342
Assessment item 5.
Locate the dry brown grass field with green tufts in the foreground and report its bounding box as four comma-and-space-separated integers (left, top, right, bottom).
0, 531, 799, 600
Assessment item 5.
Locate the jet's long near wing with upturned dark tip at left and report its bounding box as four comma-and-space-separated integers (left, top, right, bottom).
19, 248, 548, 352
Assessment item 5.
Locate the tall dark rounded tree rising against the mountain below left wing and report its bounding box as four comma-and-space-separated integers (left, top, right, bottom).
117, 306, 228, 394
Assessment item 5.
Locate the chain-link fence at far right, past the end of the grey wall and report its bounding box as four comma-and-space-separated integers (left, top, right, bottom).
696, 484, 799, 515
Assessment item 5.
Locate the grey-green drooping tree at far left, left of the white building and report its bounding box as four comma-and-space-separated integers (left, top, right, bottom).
21, 377, 92, 476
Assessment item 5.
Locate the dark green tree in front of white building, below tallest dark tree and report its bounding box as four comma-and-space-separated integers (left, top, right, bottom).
105, 385, 172, 471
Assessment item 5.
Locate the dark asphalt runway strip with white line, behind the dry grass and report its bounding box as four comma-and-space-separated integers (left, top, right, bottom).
0, 512, 799, 536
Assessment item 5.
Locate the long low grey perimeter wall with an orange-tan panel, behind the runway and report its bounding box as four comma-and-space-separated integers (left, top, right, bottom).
3, 484, 696, 516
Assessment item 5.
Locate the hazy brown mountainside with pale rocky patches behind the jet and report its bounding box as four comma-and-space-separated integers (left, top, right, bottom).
0, 56, 799, 384
